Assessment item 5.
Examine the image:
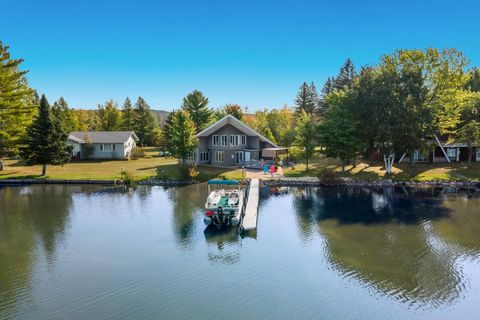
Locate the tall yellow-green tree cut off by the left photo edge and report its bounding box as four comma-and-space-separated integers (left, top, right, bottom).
0, 41, 36, 170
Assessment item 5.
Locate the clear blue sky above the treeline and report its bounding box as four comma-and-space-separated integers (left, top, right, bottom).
0, 0, 480, 111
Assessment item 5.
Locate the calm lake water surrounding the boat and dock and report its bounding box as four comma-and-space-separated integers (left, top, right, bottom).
0, 185, 480, 320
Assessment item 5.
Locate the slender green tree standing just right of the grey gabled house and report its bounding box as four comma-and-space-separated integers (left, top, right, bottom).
295, 110, 317, 171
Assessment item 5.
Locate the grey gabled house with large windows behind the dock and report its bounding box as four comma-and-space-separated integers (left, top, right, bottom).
187, 115, 287, 166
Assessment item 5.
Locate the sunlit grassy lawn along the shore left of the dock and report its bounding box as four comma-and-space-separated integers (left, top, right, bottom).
0, 148, 242, 181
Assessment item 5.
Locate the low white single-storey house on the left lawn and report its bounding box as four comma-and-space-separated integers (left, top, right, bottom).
67, 131, 138, 160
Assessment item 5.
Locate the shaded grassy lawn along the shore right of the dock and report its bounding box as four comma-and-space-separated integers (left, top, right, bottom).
284, 155, 480, 181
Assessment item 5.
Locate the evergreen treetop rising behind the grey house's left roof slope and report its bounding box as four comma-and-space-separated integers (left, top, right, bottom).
182, 90, 212, 132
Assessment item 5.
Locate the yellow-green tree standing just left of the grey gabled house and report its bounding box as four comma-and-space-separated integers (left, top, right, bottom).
168, 110, 198, 164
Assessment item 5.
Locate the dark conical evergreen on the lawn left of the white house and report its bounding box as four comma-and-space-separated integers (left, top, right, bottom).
21, 95, 71, 176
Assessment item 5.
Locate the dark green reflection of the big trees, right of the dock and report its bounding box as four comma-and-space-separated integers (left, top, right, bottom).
286, 188, 479, 306
